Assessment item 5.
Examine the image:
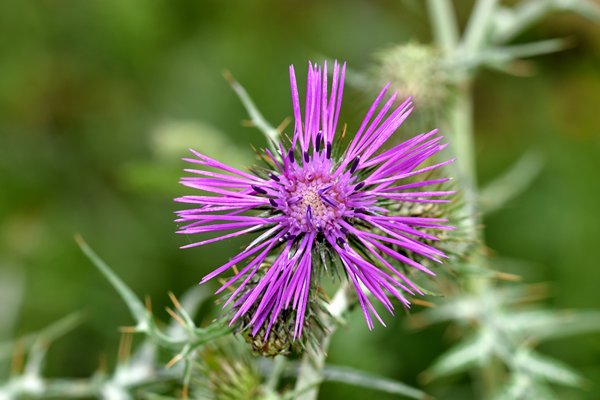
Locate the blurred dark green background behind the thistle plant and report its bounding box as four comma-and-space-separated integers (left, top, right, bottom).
0, 0, 600, 399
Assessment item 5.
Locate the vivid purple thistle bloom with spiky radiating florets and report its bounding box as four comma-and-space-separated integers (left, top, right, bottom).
176, 63, 453, 337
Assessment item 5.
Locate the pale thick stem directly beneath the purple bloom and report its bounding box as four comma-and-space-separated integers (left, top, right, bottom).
295, 284, 349, 400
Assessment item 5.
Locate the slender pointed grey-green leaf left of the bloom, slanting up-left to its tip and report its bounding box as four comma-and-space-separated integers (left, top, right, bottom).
75, 235, 148, 331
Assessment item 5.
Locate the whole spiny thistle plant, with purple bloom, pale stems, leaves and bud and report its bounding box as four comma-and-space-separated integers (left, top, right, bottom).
0, 0, 600, 400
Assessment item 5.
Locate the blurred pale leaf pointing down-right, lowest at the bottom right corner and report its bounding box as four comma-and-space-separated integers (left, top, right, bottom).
512, 348, 584, 387
